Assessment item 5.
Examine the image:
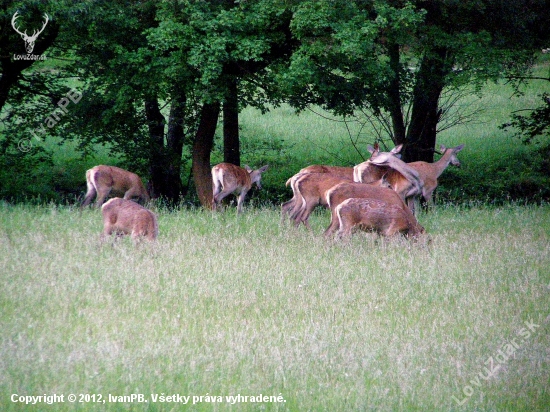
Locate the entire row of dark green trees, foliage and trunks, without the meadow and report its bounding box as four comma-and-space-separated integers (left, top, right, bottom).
0, 0, 550, 205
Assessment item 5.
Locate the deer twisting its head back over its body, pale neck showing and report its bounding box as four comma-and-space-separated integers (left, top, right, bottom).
353, 145, 424, 213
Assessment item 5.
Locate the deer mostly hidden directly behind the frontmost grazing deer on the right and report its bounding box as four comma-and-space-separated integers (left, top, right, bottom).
325, 182, 414, 236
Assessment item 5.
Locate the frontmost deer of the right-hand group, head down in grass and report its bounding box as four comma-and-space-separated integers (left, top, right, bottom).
335, 198, 425, 238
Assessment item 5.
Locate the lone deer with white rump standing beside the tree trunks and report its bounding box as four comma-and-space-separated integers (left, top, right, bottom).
212, 163, 268, 213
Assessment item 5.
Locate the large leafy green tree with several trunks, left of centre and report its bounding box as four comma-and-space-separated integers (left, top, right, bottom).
55, 0, 296, 207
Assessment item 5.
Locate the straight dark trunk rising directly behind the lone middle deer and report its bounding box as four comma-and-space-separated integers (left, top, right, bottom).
223, 77, 241, 166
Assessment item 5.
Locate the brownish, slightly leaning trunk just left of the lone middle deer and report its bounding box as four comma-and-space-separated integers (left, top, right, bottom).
191, 102, 220, 209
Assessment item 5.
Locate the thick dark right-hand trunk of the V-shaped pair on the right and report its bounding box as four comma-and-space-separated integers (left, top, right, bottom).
403, 48, 450, 163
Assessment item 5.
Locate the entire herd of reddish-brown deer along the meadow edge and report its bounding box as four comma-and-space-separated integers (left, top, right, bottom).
81, 145, 464, 242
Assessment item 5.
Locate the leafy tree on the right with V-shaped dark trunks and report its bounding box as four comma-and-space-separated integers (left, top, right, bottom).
282, 0, 549, 161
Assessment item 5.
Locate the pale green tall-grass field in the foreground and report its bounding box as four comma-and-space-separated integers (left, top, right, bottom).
0, 203, 550, 411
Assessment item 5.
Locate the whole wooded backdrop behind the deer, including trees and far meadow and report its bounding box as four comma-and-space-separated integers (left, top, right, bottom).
0, 0, 550, 205
